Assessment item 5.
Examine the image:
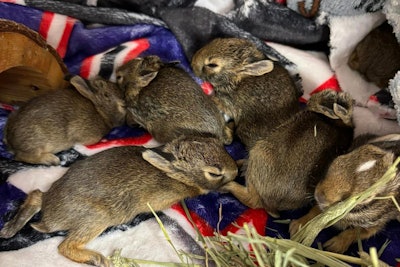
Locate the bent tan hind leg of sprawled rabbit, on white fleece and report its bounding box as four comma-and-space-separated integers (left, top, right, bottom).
58, 226, 112, 267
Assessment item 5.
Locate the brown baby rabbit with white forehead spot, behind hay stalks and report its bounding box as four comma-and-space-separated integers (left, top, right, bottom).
290, 134, 400, 253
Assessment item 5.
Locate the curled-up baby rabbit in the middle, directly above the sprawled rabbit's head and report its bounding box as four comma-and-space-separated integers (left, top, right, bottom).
117, 56, 232, 144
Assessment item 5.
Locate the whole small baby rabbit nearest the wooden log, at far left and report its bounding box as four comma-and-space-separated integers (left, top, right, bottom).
4, 76, 126, 165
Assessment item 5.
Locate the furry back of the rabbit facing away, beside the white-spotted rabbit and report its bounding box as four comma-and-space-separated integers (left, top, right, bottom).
246, 110, 353, 212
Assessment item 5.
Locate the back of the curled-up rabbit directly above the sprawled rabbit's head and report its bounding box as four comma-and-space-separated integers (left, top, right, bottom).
133, 67, 225, 143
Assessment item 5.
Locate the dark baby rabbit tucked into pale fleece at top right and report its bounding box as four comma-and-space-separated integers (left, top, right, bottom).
348, 22, 400, 88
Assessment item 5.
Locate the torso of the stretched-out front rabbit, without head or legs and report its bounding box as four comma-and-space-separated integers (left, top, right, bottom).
35, 147, 198, 232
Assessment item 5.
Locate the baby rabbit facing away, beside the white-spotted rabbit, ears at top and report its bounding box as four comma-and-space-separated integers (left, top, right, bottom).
223, 90, 353, 217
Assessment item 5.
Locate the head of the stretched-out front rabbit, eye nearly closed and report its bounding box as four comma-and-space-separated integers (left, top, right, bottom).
143, 137, 238, 190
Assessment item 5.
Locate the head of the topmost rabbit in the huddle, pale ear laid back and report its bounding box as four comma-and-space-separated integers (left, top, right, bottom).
192, 38, 274, 92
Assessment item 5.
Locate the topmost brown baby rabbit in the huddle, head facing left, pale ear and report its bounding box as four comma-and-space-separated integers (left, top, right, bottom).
192, 38, 302, 148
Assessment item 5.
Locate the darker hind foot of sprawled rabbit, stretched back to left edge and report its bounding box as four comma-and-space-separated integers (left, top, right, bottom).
0, 190, 43, 238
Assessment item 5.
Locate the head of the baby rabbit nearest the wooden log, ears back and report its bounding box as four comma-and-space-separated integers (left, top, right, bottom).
70, 75, 126, 128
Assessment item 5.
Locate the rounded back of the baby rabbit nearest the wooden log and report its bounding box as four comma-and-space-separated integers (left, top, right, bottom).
5, 89, 109, 163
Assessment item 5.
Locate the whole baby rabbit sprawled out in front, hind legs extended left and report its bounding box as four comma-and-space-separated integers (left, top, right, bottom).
0, 137, 237, 266
